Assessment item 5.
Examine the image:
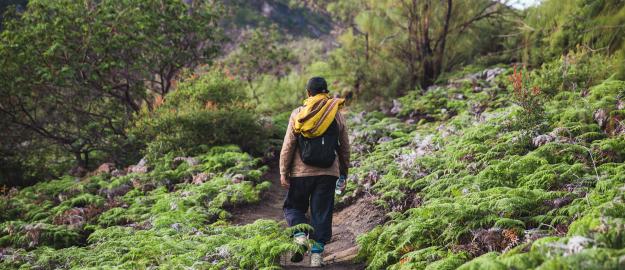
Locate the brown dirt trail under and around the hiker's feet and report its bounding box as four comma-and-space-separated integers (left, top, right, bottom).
232, 166, 384, 270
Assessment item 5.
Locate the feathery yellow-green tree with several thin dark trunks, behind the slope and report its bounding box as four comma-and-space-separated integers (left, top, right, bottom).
328, 0, 511, 94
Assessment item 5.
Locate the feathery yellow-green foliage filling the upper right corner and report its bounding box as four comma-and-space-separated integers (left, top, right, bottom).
521, 0, 625, 65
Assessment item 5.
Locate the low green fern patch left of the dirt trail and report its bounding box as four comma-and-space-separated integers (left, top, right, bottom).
0, 146, 297, 269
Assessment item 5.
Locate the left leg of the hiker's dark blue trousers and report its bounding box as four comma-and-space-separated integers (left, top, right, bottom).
282, 177, 312, 226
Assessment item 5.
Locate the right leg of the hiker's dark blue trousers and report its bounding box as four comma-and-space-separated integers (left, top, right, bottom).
310, 176, 337, 245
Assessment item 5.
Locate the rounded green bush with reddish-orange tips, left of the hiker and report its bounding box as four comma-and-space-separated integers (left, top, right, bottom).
131, 71, 268, 159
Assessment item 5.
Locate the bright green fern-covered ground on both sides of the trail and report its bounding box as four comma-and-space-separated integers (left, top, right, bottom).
1, 59, 625, 269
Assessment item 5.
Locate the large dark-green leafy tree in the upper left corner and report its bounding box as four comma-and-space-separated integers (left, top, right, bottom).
0, 0, 222, 167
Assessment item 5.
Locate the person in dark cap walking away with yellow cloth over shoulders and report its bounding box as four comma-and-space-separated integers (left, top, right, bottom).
280, 77, 349, 267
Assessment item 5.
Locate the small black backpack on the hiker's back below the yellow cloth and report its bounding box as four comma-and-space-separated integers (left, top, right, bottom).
297, 119, 339, 168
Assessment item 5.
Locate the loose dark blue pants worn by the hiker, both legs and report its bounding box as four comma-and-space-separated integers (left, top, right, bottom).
283, 175, 337, 245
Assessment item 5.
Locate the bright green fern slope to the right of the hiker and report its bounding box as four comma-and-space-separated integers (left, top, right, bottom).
340, 54, 625, 269
